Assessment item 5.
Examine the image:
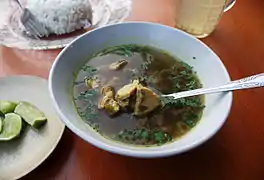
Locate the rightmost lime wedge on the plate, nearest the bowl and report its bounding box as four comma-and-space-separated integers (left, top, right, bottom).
15, 102, 47, 129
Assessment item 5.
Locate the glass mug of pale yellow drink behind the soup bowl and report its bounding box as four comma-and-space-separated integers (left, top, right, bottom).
175, 0, 236, 38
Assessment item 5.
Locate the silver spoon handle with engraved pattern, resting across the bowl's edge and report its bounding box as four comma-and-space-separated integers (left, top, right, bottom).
163, 73, 264, 99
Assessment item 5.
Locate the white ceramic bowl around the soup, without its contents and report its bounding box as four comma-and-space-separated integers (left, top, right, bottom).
49, 22, 232, 158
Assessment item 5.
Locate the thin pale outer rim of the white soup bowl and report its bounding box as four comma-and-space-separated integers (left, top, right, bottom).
49, 21, 233, 158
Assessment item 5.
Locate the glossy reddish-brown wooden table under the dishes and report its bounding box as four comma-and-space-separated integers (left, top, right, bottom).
0, 0, 264, 180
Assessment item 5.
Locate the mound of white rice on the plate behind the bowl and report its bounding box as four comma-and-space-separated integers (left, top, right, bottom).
26, 0, 92, 36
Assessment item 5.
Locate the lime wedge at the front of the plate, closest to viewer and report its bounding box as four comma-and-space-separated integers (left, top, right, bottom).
0, 113, 22, 141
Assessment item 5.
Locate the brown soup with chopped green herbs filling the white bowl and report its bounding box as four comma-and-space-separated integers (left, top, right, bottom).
73, 45, 204, 146
